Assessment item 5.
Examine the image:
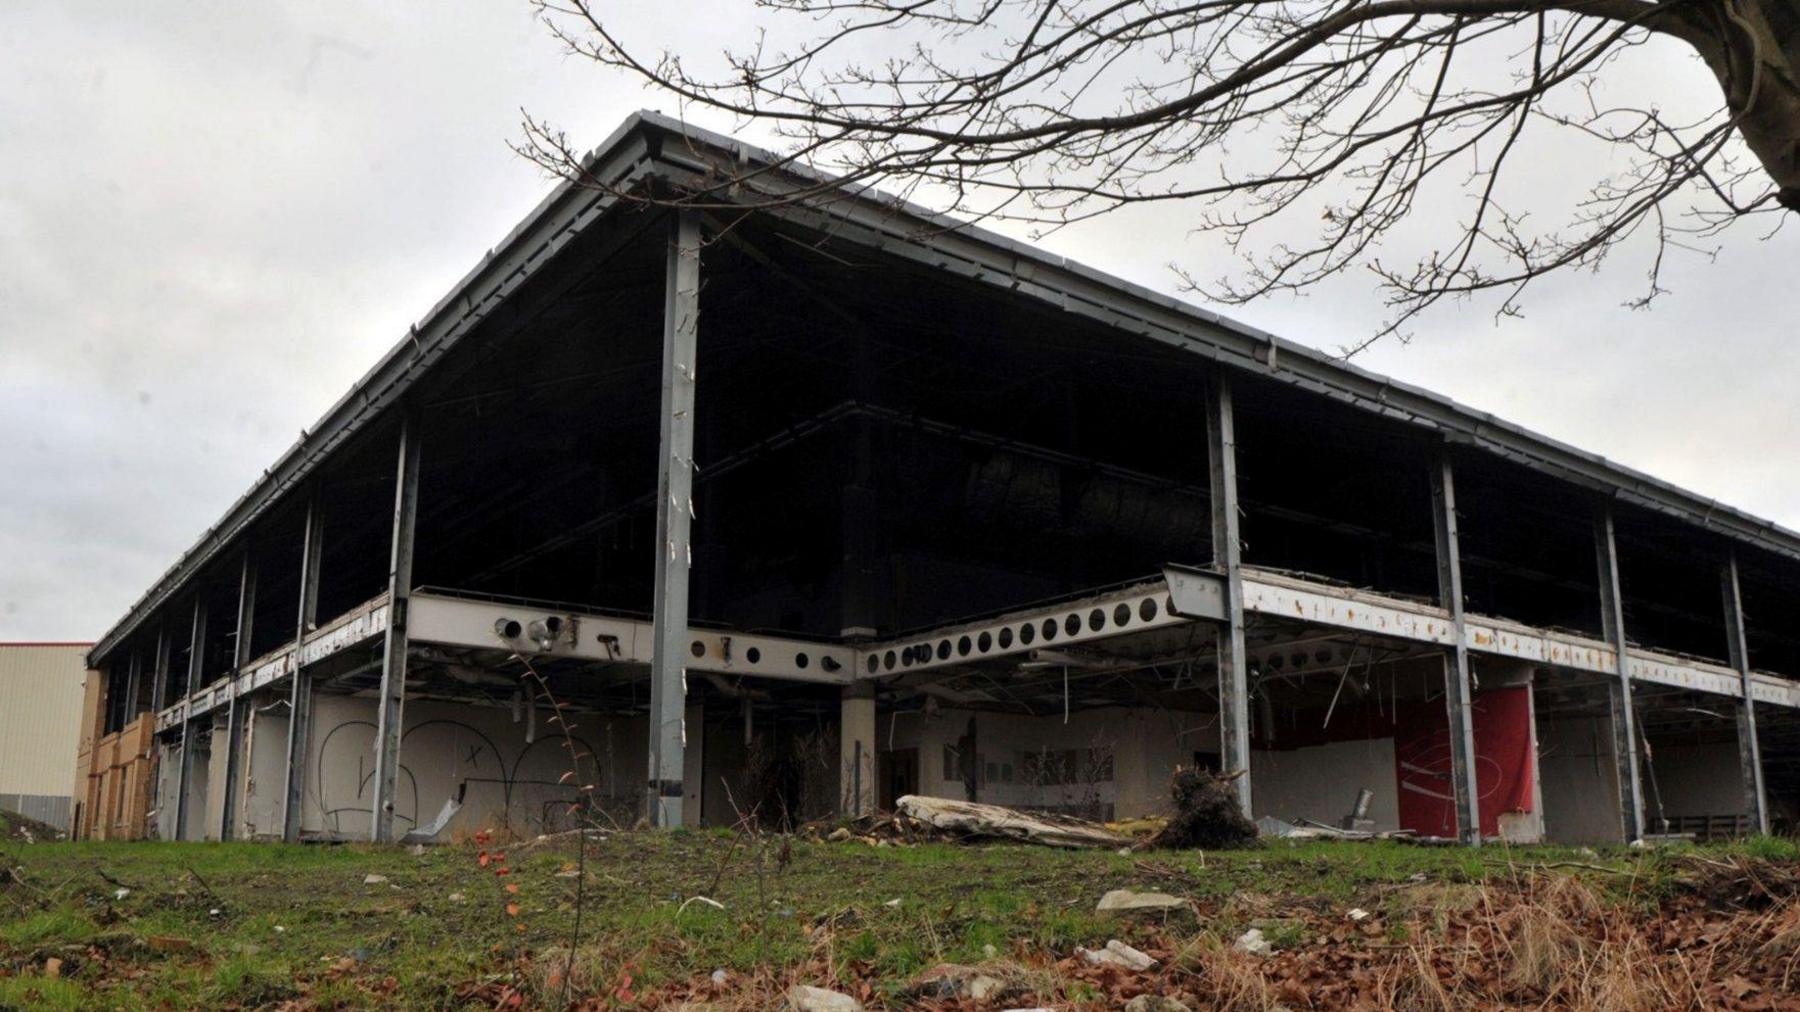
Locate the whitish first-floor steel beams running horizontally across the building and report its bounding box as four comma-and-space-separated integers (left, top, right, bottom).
157, 567, 1800, 720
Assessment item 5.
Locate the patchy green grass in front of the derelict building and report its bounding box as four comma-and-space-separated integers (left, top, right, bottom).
0, 830, 1771, 1008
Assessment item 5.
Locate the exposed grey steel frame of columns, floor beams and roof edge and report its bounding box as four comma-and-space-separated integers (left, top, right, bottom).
90, 113, 1800, 843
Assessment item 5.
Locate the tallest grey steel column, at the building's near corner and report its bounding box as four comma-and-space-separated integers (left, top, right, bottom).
644, 211, 700, 827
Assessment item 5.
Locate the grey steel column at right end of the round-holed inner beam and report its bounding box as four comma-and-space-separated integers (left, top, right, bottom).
1206, 369, 1255, 818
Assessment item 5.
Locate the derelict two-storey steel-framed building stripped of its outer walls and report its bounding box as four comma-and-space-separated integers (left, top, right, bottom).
76, 113, 1800, 843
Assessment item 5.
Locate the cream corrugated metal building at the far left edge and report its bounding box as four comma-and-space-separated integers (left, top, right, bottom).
0, 643, 88, 813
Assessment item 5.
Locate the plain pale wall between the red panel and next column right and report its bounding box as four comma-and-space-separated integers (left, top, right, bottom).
1537, 717, 1625, 843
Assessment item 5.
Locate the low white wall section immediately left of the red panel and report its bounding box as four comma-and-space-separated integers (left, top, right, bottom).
1249, 738, 1400, 830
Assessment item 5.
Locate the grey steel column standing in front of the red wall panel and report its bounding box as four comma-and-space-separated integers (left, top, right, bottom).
1431, 450, 1481, 846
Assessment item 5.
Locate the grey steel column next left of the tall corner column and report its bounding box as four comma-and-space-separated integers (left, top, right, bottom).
369, 412, 419, 843
